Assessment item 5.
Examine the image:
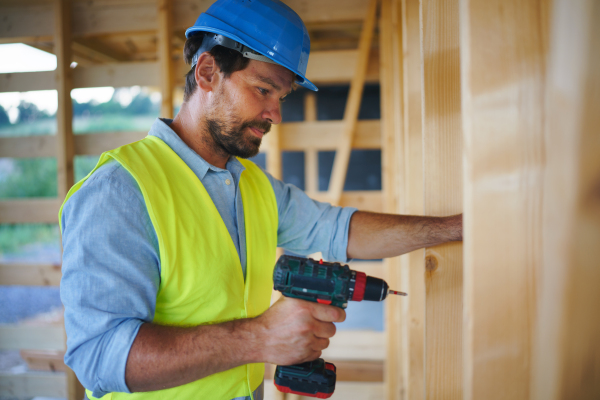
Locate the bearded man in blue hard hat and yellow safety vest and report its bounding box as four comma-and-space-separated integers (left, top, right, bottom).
60, 0, 462, 400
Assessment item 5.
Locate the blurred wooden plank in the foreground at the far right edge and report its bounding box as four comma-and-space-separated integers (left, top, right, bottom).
530, 0, 600, 400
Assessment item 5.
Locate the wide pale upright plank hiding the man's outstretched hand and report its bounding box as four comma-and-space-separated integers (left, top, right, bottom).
460, 0, 549, 400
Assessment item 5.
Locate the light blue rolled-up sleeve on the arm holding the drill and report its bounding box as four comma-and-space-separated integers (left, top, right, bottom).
60, 162, 160, 397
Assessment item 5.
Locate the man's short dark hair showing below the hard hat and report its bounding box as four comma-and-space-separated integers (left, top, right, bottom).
183, 33, 250, 101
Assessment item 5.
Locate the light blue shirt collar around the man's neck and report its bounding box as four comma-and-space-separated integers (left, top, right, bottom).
148, 118, 245, 180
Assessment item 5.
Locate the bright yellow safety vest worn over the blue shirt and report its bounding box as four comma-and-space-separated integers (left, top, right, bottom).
59, 136, 278, 400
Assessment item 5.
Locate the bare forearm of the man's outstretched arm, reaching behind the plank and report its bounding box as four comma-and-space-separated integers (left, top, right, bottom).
348, 211, 462, 259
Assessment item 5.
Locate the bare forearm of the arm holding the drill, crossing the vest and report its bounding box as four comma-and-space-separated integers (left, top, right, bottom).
125, 319, 261, 392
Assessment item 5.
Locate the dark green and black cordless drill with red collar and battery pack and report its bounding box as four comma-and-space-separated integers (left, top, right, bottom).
273, 255, 406, 399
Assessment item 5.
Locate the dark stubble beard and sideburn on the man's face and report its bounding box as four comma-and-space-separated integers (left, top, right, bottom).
205, 85, 271, 158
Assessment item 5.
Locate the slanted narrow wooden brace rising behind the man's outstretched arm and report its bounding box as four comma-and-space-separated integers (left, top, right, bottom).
328, 0, 378, 204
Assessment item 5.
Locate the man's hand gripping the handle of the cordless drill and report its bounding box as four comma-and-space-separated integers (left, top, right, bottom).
253, 297, 346, 365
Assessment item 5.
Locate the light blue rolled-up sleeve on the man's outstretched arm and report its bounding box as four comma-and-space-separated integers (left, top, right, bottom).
267, 173, 357, 262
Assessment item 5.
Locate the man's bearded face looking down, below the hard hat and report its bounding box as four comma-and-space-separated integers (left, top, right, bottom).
206, 60, 294, 158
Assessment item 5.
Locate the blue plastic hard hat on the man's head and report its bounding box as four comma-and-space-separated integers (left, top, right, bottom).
185, 0, 318, 91
